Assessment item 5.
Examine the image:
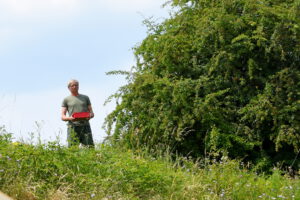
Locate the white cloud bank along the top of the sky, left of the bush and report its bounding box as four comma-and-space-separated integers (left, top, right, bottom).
0, 0, 166, 51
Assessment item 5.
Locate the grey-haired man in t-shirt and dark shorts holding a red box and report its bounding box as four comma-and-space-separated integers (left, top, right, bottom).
61, 80, 94, 147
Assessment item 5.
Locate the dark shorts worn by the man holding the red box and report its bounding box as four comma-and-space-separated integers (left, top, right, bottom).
68, 124, 94, 147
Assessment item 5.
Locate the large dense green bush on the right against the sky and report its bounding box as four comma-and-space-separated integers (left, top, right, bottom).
106, 0, 300, 171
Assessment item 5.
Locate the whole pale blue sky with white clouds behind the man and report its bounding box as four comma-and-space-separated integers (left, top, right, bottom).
0, 0, 169, 143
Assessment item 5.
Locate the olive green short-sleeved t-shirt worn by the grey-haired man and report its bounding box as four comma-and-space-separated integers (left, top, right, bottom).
62, 94, 91, 124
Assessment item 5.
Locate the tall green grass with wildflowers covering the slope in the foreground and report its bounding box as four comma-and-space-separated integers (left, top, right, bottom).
0, 135, 300, 200
